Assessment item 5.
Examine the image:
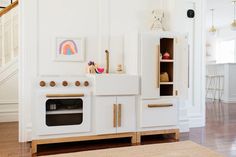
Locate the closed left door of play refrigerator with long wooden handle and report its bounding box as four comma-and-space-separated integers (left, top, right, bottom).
141, 33, 160, 99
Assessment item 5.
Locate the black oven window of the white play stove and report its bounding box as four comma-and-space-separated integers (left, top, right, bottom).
46, 98, 83, 127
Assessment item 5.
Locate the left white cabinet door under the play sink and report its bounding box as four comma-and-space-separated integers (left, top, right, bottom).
95, 96, 117, 134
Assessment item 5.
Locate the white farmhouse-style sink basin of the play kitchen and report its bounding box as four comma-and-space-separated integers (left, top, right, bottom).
90, 74, 139, 95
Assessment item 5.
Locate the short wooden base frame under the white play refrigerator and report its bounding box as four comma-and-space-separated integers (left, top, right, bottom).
136, 129, 179, 144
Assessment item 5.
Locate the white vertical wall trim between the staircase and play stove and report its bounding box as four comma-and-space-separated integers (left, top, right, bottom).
19, 0, 39, 142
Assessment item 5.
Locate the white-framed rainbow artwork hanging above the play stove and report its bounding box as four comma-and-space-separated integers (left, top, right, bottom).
55, 38, 84, 62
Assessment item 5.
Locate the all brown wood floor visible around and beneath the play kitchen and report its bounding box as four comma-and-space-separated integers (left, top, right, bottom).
0, 102, 236, 157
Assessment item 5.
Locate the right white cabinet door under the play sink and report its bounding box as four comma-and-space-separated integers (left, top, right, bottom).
117, 96, 136, 133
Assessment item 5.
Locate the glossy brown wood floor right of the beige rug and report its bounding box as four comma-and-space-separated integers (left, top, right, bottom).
185, 101, 236, 157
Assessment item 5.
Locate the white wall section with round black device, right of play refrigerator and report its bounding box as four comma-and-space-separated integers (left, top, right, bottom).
168, 0, 206, 127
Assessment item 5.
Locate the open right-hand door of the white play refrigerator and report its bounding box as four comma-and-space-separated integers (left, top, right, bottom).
174, 36, 189, 99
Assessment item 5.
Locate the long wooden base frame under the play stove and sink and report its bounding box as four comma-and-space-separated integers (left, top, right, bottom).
31, 132, 137, 154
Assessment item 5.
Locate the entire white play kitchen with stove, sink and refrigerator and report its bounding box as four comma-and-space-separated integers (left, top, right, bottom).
32, 32, 189, 153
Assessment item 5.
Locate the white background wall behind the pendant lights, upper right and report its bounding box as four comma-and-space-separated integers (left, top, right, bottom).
205, 0, 236, 63
